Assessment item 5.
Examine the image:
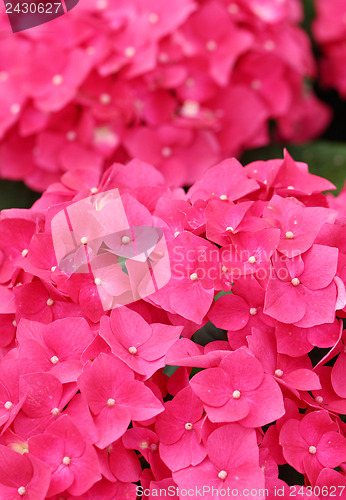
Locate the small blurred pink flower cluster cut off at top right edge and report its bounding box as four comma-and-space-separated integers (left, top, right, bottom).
313, 0, 346, 98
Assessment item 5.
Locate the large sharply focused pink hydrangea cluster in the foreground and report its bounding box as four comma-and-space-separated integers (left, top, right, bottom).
0, 153, 346, 500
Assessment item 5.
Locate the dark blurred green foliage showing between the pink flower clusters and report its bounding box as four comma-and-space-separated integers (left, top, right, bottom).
0, 0, 346, 210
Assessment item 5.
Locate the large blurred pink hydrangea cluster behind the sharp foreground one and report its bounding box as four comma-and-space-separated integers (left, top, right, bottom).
0, 0, 330, 191
